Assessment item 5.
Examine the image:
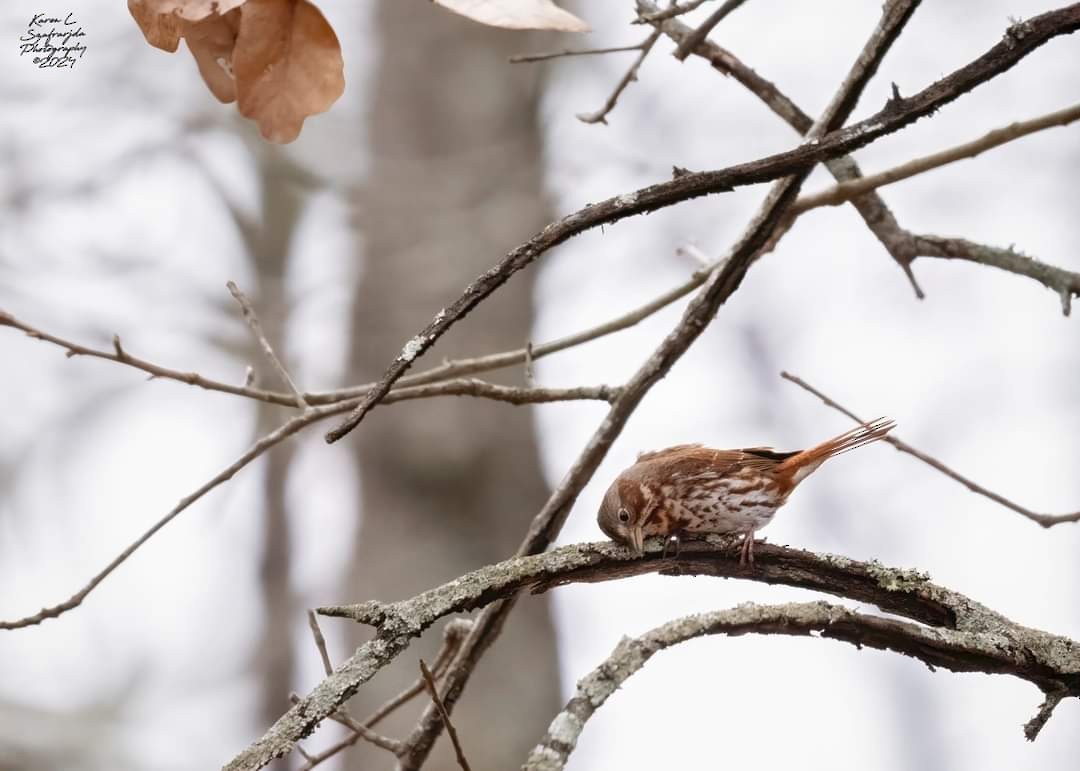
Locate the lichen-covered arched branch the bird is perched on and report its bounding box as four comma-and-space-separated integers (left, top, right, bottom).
226, 536, 1080, 771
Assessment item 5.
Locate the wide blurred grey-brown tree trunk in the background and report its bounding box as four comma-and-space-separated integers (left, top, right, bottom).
342, 2, 559, 771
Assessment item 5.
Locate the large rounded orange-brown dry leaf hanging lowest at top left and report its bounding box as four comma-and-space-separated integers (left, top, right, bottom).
232, 0, 345, 143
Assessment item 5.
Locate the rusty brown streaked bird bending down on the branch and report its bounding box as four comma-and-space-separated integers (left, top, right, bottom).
597, 418, 895, 565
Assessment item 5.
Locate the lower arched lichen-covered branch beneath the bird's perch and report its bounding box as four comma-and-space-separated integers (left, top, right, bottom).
522, 603, 1064, 771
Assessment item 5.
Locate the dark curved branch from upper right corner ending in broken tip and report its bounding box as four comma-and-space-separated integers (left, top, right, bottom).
326, 3, 1080, 442
